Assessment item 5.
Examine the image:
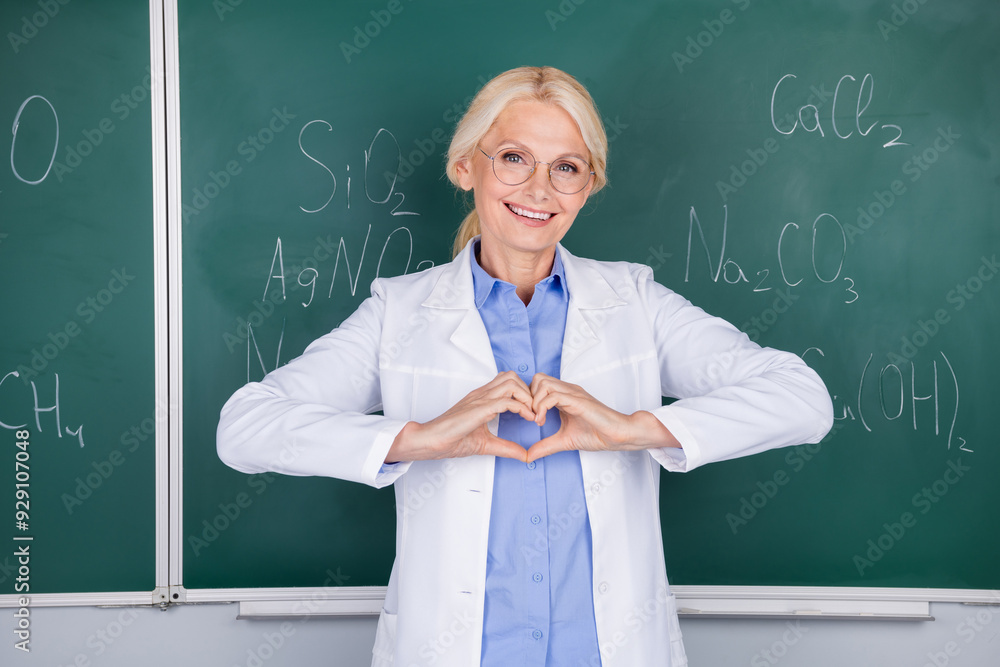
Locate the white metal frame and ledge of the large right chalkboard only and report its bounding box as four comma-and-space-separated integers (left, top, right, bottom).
164, 0, 1000, 621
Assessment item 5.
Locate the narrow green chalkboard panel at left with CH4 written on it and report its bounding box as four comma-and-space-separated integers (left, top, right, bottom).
0, 0, 156, 595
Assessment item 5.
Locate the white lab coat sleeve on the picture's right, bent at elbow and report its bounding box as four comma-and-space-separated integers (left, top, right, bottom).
635, 267, 833, 472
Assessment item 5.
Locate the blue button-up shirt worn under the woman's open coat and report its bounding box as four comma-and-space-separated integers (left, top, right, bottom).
471, 241, 599, 667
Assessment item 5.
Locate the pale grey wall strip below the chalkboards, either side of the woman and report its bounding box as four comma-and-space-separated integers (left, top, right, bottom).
0, 603, 1000, 667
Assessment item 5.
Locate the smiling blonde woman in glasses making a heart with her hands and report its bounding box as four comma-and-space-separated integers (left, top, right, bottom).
218, 67, 833, 667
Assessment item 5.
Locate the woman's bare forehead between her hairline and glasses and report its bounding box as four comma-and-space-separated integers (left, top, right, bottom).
483, 101, 590, 157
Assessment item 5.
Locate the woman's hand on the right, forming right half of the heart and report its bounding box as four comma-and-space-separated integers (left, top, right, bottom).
527, 373, 681, 462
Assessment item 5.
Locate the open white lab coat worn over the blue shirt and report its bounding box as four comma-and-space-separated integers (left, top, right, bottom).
218, 244, 833, 667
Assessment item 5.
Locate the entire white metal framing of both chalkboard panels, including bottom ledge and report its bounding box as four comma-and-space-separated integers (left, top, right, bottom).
0, 0, 1000, 620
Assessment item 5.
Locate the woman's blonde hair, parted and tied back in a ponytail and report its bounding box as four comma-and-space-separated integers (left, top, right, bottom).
446, 67, 608, 257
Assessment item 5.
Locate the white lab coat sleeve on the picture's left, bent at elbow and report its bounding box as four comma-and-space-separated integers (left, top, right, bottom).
216, 280, 409, 487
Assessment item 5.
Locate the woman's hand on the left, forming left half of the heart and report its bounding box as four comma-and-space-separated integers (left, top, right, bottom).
385, 371, 535, 463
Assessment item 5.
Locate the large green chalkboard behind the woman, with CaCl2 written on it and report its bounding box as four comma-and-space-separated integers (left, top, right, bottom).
179, 0, 1000, 589
